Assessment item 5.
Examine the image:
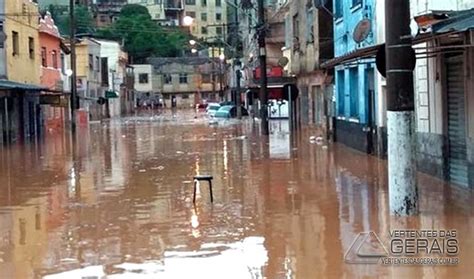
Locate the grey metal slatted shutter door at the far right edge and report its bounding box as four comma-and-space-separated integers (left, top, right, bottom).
446, 55, 468, 186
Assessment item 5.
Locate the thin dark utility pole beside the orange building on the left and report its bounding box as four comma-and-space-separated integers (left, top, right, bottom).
69, 0, 77, 136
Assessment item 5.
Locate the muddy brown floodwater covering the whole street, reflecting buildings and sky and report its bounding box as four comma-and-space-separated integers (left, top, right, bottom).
0, 110, 474, 278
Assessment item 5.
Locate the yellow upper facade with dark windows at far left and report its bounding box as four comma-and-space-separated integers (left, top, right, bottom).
4, 0, 41, 85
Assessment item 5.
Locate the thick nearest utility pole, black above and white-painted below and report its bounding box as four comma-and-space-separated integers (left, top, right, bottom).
385, 0, 418, 215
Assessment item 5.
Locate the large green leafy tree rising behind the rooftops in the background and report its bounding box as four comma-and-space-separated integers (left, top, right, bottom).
96, 4, 188, 63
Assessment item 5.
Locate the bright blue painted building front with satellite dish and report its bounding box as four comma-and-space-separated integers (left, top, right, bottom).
333, 0, 377, 153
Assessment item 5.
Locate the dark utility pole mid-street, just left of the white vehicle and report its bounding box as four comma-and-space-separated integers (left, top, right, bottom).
257, 0, 269, 136
